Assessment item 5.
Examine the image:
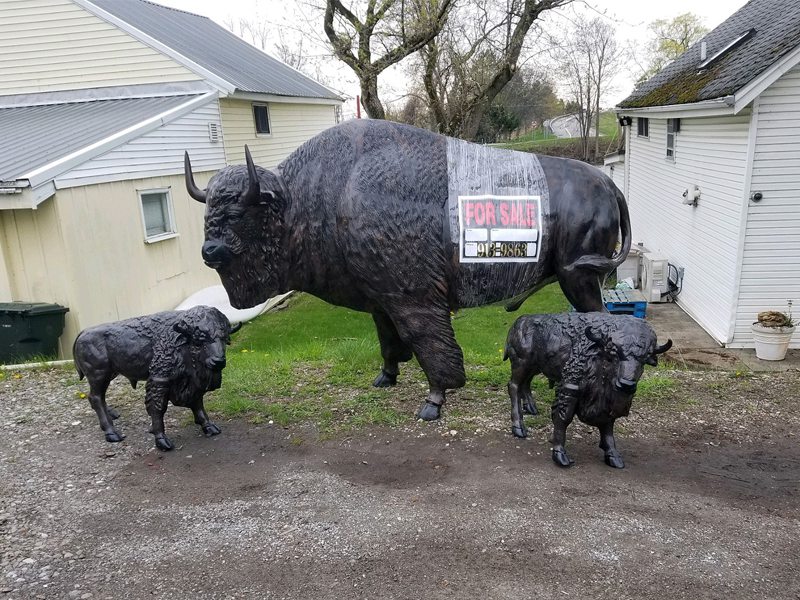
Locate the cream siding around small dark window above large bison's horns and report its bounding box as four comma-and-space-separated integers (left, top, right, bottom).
220, 98, 336, 168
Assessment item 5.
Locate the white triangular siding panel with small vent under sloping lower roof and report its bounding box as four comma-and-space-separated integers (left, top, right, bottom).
56, 100, 225, 189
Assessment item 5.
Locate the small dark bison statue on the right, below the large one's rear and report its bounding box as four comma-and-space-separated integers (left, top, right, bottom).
504, 312, 672, 469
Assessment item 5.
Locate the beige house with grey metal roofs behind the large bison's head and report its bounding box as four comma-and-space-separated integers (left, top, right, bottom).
0, 0, 342, 356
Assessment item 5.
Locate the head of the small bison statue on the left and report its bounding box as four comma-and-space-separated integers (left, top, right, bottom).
172, 306, 235, 371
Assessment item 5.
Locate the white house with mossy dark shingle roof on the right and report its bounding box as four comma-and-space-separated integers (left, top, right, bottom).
616, 0, 800, 348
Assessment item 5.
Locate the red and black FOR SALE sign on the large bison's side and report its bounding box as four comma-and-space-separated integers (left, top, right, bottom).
458, 195, 542, 263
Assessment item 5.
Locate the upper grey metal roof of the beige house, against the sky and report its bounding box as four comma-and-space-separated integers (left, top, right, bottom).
86, 0, 341, 100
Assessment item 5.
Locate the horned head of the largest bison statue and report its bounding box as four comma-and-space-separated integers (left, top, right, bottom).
184, 146, 287, 308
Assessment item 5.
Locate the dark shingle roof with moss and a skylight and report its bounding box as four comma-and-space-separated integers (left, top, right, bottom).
618, 0, 800, 108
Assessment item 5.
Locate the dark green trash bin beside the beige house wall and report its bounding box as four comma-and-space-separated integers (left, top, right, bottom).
0, 302, 69, 364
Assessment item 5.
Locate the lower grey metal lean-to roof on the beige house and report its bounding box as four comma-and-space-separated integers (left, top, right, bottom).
0, 94, 206, 186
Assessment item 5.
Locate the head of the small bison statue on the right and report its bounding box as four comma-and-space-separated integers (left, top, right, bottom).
585, 319, 672, 396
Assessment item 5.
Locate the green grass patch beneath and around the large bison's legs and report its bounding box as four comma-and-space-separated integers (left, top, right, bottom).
207, 284, 669, 435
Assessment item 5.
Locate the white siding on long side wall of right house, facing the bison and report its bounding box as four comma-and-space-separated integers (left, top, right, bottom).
627, 114, 750, 343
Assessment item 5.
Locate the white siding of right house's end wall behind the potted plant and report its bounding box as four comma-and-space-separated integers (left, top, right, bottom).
731, 66, 800, 348
